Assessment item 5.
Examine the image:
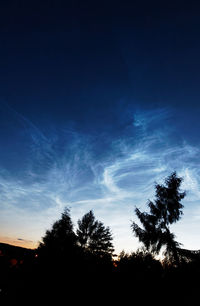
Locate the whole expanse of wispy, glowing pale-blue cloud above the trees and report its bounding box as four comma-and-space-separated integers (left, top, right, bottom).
0, 109, 200, 252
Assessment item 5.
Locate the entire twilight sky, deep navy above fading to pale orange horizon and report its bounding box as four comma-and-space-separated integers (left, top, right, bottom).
0, 0, 200, 253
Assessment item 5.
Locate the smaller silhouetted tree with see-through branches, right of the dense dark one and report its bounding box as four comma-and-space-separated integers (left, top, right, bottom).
77, 210, 114, 256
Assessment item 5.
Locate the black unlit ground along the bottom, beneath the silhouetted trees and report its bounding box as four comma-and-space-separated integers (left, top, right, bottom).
0, 243, 200, 305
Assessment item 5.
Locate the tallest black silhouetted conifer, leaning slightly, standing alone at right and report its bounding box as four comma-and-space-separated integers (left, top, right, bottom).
131, 172, 185, 262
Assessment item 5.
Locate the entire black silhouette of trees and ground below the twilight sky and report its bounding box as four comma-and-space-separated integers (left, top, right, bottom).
0, 173, 200, 305
